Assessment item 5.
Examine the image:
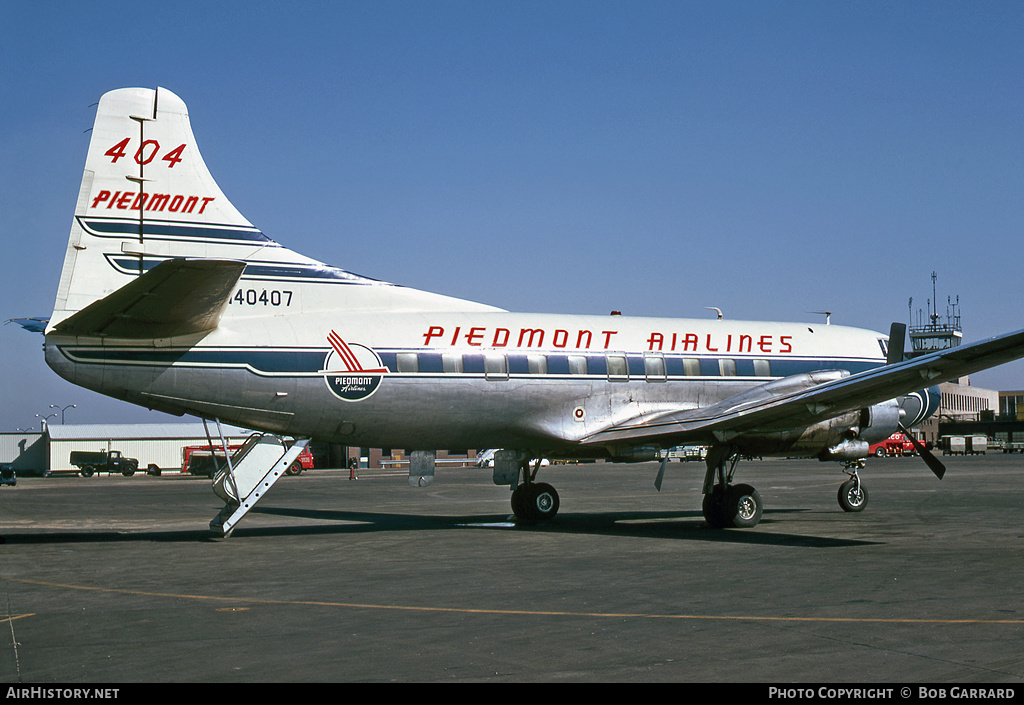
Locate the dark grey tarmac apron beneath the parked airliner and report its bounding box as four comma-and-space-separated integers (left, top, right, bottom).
0, 455, 1024, 684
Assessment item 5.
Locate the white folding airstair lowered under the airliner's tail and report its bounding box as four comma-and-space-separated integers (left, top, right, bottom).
210, 433, 309, 538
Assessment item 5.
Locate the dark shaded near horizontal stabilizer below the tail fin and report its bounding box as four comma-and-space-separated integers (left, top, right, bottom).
51, 259, 246, 339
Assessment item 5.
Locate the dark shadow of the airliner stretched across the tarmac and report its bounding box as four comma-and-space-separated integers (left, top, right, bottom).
0, 505, 879, 548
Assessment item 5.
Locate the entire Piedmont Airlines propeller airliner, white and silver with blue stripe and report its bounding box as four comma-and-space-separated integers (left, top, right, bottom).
36, 88, 1024, 535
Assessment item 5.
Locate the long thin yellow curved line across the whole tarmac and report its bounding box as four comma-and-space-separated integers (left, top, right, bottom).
0, 575, 1024, 625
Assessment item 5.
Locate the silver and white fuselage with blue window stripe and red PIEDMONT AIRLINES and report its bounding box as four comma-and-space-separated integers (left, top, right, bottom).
46, 309, 897, 455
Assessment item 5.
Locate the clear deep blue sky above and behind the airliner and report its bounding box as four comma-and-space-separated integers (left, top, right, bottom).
0, 0, 1024, 430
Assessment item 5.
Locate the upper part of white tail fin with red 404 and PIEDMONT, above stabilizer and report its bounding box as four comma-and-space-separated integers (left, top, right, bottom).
50, 88, 276, 328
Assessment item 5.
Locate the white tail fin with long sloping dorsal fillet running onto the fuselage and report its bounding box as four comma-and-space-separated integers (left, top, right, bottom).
47, 88, 496, 332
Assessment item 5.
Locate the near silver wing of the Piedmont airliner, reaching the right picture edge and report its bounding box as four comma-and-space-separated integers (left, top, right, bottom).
584, 330, 1024, 446
